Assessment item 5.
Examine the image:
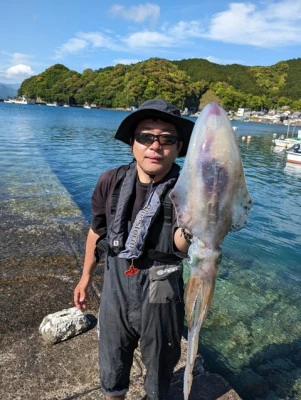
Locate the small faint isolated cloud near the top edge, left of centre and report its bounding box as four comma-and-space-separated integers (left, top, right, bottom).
109, 3, 160, 23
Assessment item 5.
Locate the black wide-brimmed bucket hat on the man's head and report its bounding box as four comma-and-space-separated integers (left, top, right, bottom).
115, 99, 194, 157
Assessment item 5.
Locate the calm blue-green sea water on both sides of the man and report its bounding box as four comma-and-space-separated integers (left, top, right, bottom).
0, 103, 301, 400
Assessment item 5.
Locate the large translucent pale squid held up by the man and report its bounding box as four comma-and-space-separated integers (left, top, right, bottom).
170, 103, 252, 400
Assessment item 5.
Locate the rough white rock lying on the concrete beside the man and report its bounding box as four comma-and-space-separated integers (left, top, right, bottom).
39, 307, 91, 344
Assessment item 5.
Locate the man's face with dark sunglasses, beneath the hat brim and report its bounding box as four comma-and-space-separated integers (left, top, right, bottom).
132, 119, 182, 183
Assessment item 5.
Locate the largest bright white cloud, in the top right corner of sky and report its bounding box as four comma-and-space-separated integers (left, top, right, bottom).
204, 0, 301, 48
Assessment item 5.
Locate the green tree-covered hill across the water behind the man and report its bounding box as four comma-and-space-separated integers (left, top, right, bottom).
19, 58, 301, 110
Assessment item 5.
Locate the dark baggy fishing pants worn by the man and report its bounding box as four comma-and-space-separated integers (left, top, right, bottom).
99, 257, 184, 400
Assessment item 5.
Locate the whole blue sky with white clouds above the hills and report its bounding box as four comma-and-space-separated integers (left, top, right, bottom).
0, 0, 301, 83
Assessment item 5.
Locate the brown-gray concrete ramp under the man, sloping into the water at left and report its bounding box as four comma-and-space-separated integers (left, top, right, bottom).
0, 158, 240, 400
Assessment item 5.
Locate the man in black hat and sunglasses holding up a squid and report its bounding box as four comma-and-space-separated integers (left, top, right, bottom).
74, 99, 194, 400
